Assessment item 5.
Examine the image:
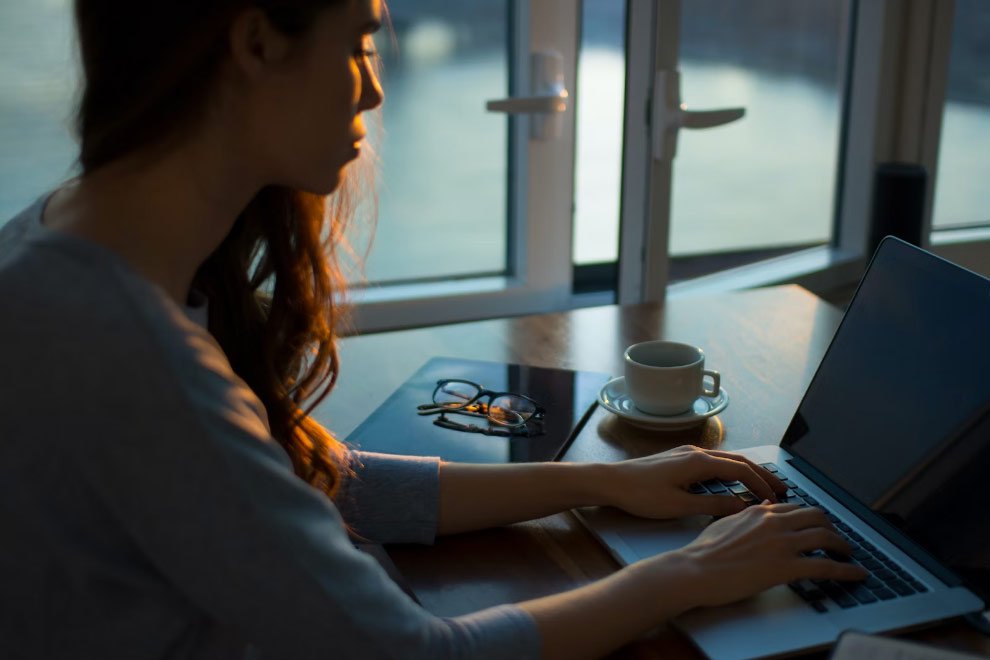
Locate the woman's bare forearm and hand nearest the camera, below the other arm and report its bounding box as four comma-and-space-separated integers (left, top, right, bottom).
521, 502, 865, 659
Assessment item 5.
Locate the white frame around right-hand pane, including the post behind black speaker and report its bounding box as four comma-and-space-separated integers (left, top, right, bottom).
618, 0, 990, 303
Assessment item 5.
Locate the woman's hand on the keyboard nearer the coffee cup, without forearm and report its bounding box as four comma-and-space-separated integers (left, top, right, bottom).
602, 445, 787, 518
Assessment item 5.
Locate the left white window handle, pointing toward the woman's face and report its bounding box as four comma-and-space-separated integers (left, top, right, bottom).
485, 51, 570, 140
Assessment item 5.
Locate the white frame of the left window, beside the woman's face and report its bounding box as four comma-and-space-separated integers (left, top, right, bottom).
348, 0, 580, 332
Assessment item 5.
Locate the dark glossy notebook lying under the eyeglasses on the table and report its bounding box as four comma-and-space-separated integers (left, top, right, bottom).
347, 357, 609, 463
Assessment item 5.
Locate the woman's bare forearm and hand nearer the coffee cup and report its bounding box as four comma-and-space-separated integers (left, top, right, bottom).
438, 446, 786, 534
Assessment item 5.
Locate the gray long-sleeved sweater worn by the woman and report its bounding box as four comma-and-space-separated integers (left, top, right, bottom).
0, 195, 540, 660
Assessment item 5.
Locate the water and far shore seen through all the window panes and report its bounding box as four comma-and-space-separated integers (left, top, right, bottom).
0, 0, 990, 282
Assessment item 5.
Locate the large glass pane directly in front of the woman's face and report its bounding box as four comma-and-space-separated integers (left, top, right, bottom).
358, 0, 509, 282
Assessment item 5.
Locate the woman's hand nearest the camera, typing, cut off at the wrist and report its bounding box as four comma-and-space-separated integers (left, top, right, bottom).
661, 502, 866, 606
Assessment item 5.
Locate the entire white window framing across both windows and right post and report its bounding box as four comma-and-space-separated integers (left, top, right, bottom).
357, 0, 990, 331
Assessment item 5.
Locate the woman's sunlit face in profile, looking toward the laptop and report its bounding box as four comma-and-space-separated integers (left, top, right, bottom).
248, 0, 383, 194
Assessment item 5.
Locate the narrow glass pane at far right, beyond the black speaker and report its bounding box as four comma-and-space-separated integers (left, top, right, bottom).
932, 0, 990, 229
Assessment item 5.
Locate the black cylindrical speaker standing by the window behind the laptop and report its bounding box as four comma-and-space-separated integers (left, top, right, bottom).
870, 163, 928, 254
